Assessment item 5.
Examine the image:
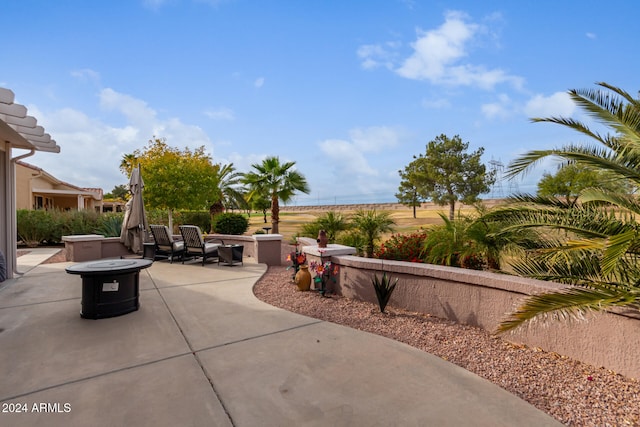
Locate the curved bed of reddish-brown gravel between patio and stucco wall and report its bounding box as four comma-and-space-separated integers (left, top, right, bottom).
254, 266, 640, 427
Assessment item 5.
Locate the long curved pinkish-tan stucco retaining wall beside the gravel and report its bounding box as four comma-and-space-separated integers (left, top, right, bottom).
332, 256, 640, 378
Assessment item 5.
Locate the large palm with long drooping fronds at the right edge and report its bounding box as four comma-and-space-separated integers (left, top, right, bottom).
485, 83, 640, 331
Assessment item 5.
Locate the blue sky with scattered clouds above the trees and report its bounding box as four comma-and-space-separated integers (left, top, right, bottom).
0, 0, 640, 205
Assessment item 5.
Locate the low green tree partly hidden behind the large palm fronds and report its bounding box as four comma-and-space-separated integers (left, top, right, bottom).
538, 163, 631, 203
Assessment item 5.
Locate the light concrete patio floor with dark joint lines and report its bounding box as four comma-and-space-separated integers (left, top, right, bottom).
0, 254, 560, 427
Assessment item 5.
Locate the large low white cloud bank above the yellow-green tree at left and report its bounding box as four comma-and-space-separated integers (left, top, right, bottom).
26, 89, 213, 192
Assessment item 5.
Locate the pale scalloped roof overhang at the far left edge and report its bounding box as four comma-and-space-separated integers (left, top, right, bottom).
0, 87, 60, 153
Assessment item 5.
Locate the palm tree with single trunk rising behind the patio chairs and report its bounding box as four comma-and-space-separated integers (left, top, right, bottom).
242, 156, 310, 233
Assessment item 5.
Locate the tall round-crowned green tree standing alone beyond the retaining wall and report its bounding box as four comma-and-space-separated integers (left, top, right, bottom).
409, 134, 495, 220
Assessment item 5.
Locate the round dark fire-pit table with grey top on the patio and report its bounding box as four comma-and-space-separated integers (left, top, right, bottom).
66, 258, 153, 319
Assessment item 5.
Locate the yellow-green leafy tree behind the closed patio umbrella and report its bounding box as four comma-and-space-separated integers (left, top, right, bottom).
121, 138, 220, 230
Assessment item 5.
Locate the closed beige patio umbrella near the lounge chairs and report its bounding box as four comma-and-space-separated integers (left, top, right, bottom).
120, 166, 148, 253
